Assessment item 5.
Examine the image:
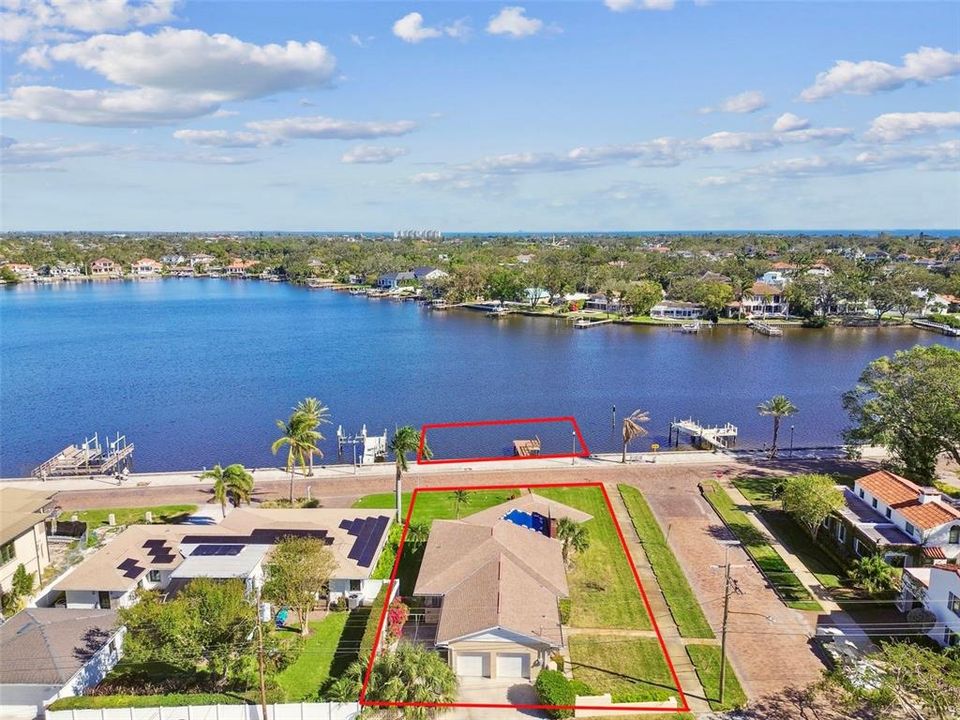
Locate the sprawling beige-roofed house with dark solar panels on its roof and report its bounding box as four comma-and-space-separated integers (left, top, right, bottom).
54, 508, 390, 608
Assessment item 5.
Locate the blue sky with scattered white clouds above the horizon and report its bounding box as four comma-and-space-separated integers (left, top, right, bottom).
0, 0, 960, 231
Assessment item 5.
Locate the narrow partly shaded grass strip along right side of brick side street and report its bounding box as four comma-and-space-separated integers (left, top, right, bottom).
703, 481, 823, 611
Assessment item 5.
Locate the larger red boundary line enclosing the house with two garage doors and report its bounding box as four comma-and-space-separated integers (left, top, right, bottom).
358, 482, 690, 714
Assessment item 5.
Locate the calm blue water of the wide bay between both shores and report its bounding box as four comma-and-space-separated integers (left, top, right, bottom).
0, 279, 960, 477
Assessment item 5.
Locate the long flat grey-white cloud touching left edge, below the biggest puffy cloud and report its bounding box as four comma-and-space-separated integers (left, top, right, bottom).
0, 85, 217, 127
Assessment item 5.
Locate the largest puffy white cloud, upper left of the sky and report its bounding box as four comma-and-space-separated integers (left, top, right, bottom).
28, 28, 336, 102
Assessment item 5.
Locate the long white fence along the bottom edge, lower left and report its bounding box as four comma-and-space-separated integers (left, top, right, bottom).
46, 702, 360, 720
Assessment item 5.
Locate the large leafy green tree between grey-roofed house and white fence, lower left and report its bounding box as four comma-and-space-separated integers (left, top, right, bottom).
118, 578, 257, 688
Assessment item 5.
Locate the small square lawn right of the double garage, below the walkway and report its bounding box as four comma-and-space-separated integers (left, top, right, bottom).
570, 635, 677, 702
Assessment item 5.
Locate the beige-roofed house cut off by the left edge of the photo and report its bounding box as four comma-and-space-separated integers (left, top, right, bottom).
0, 487, 53, 592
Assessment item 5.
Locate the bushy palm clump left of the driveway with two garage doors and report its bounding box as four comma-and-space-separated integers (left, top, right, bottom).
327, 641, 457, 720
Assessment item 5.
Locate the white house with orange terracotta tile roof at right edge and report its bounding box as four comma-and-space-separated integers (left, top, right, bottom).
818, 470, 960, 567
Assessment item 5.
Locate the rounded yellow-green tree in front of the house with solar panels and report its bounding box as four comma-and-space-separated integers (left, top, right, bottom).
263, 537, 337, 636
